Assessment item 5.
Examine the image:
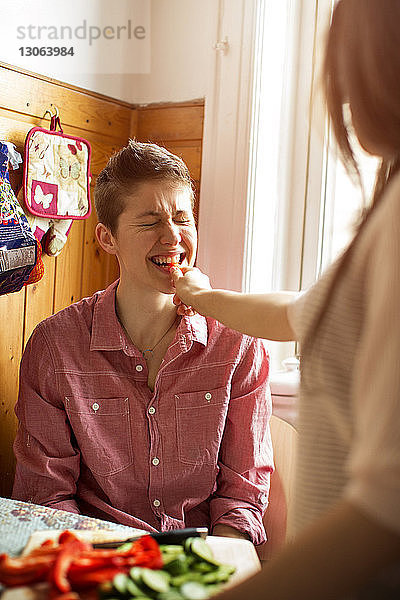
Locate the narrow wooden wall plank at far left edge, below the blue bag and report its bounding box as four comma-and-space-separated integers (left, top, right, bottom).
0, 289, 25, 496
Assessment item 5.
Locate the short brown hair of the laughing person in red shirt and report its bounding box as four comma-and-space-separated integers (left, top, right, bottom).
95, 140, 193, 233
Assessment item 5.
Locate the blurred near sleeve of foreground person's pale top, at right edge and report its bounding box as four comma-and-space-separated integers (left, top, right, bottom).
346, 197, 400, 532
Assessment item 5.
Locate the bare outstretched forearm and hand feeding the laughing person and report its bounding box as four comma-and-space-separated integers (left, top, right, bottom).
171, 268, 297, 342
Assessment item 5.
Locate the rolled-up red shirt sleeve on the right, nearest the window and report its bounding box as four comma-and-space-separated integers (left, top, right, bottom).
210, 338, 273, 544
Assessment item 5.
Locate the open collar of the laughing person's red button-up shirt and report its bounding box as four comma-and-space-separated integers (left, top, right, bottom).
90, 280, 208, 352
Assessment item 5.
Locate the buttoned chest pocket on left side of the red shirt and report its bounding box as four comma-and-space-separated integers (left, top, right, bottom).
65, 396, 133, 476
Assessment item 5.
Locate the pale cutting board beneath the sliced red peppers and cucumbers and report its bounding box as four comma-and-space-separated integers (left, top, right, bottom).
1, 529, 261, 600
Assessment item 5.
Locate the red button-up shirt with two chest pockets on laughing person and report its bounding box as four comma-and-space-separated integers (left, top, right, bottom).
13, 282, 273, 544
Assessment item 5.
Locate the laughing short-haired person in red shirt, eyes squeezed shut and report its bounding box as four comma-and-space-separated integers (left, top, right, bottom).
13, 141, 272, 544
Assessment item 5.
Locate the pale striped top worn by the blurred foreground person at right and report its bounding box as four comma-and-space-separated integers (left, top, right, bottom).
289, 169, 400, 597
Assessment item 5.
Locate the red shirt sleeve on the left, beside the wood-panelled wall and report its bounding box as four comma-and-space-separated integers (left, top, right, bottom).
13, 326, 80, 513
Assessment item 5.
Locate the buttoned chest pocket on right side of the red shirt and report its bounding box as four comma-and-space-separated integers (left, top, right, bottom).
175, 387, 229, 465
